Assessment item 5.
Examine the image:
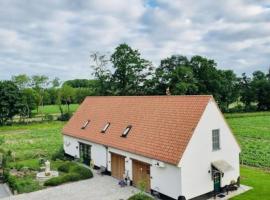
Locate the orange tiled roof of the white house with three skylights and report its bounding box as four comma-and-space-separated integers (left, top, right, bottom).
63, 95, 212, 165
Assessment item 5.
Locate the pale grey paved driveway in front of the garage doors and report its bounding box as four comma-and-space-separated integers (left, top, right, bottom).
1, 173, 138, 200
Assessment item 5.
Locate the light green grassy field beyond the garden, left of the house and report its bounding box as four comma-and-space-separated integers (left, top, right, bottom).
0, 121, 64, 161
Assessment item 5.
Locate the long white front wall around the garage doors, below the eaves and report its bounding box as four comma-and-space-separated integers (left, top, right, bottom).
63, 135, 181, 199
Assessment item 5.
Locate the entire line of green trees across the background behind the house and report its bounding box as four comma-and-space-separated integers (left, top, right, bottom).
0, 44, 270, 124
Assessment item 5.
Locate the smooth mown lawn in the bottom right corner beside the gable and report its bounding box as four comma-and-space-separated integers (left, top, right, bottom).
232, 167, 270, 200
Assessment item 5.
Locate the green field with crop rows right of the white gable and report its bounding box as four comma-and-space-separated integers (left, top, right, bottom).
225, 112, 270, 168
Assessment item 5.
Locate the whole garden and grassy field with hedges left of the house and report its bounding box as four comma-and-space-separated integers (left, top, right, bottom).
0, 122, 93, 194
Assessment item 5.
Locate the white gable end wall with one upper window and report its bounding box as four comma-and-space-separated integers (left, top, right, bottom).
179, 101, 240, 199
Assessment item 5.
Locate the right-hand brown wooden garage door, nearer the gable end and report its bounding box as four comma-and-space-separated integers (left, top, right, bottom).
132, 160, 151, 192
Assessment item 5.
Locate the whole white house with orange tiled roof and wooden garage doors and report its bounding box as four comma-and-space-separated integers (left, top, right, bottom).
63, 95, 240, 199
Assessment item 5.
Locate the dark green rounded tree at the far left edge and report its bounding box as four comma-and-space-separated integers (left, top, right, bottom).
0, 81, 22, 125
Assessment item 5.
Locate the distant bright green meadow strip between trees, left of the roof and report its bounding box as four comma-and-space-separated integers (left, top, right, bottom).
32, 104, 79, 114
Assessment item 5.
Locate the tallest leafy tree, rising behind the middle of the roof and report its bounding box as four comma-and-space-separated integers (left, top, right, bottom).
110, 44, 152, 95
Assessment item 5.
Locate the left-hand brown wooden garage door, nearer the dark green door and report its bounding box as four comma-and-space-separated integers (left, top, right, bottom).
111, 153, 125, 180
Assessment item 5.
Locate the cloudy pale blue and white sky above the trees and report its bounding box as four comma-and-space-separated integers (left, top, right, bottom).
0, 0, 270, 80
